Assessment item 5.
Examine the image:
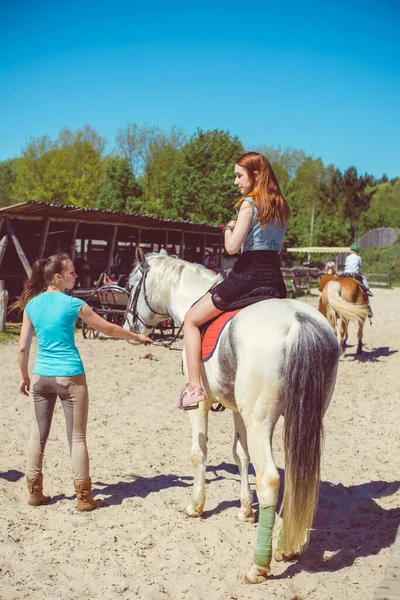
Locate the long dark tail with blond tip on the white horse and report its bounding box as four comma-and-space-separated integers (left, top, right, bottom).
281, 312, 339, 554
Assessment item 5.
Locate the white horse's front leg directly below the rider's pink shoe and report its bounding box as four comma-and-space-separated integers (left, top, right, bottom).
185, 400, 210, 517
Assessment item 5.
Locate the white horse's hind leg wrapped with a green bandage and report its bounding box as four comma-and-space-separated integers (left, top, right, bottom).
242, 410, 281, 583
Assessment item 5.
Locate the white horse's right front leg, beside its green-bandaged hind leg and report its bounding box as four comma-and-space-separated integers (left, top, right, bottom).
233, 412, 254, 523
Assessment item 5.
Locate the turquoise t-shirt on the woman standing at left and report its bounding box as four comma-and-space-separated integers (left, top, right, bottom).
25, 292, 85, 377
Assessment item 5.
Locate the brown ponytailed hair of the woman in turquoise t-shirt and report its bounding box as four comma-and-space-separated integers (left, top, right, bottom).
10, 254, 71, 311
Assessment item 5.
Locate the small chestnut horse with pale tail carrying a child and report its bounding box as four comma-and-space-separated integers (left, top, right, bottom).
318, 275, 369, 354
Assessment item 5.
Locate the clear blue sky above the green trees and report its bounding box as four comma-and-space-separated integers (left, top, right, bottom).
0, 0, 400, 177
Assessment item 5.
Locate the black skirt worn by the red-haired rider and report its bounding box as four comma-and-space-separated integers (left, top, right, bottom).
210, 250, 286, 310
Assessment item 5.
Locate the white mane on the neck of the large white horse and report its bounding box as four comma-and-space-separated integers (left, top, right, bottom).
146, 252, 221, 297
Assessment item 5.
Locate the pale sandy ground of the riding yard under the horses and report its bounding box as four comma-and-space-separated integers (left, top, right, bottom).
0, 289, 400, 600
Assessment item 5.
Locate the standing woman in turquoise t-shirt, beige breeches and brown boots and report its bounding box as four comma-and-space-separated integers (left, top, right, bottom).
12, 254, 151, 511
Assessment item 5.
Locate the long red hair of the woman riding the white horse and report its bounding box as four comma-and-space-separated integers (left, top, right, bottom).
235, 152, 290, 228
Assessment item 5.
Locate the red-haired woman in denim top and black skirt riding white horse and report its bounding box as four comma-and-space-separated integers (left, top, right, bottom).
179, 152, 290, 410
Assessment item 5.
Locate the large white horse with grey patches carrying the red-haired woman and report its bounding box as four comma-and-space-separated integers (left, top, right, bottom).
125, 250, 339, 583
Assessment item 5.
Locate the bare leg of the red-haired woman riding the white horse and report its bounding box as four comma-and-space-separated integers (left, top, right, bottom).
184, 292, 223, 392
